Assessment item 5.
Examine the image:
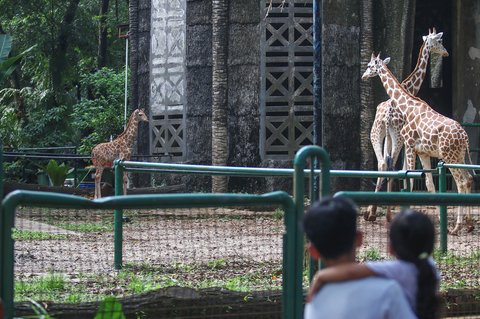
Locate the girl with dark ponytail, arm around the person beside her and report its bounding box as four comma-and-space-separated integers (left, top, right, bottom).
308, 209, 439, 319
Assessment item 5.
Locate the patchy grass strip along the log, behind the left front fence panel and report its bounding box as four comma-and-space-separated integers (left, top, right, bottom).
15, 259, 282, 303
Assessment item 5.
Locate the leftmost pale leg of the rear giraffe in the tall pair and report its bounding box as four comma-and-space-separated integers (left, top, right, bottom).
363, 115, 387, 221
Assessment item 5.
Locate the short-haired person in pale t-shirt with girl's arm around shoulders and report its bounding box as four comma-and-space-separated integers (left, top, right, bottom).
302, 197, 417, 319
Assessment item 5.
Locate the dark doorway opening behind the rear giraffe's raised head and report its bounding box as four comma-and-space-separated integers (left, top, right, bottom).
412, 0, 454, 118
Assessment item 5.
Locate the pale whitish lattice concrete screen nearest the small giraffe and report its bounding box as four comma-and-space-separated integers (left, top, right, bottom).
150, 0, 186, 160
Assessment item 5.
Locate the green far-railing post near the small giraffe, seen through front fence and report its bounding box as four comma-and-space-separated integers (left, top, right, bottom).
113, 160, 124, 270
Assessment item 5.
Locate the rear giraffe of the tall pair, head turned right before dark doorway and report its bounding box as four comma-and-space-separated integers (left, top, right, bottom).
364, 28, 448, 221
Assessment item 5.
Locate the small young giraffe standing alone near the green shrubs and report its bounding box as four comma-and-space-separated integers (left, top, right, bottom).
92, 109, 148, 198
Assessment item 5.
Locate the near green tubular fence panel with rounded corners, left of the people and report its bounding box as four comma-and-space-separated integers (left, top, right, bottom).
0, 191, 302, 318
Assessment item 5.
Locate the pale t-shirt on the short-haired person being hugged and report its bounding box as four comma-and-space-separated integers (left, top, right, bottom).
304, 277, 416, 319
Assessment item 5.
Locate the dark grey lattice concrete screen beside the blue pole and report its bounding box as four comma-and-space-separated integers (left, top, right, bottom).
261, 0, 313, 159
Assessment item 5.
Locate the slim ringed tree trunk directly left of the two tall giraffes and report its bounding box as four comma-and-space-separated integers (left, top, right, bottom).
360, 0, 376, 190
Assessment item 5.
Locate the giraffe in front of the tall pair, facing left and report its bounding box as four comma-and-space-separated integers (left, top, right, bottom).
362, 54, 473, 235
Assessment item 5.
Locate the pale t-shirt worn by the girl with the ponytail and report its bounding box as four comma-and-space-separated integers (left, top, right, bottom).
365, 258, 440, 309
